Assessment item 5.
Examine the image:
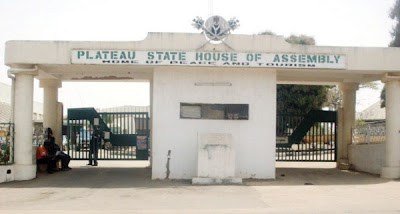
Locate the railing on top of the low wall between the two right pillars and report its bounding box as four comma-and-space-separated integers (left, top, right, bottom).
353, 121, 386, 144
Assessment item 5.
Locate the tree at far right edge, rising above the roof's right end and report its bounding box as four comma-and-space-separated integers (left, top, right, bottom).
381, 0, 400, 108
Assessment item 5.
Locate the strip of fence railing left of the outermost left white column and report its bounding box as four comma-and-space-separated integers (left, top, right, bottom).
0, 123, 14, 165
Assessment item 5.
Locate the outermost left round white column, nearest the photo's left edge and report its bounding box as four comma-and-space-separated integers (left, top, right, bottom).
14, 73, 36, 180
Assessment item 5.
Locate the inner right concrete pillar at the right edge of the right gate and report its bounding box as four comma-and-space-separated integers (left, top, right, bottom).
337, 82, 358, 169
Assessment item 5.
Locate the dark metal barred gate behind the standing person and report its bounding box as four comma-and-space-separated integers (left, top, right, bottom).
67, 108, 150, 160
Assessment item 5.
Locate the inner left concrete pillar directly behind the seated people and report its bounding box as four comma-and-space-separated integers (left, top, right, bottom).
40, 79, 62, 147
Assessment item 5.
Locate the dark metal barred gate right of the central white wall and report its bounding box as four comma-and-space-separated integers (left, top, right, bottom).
276, 110, 337, 162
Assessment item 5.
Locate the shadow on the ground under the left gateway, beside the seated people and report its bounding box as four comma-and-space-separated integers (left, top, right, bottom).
0, 167, 191, 188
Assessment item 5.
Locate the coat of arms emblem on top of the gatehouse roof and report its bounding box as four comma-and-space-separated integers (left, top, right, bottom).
192, 16, 239, 42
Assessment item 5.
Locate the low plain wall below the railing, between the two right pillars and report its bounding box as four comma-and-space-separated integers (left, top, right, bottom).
349, 143, 385, 174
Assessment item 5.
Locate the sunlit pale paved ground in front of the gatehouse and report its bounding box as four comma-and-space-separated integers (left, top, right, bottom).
0, 162, 400, 213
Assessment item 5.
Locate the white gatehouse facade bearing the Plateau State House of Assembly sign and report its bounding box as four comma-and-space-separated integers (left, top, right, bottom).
5, 33, 400, 180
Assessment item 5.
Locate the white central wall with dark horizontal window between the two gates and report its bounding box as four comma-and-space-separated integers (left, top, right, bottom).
152, 67, 276, 179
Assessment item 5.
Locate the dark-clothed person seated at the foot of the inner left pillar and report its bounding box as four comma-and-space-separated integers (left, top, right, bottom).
44, 128, 71, 173
